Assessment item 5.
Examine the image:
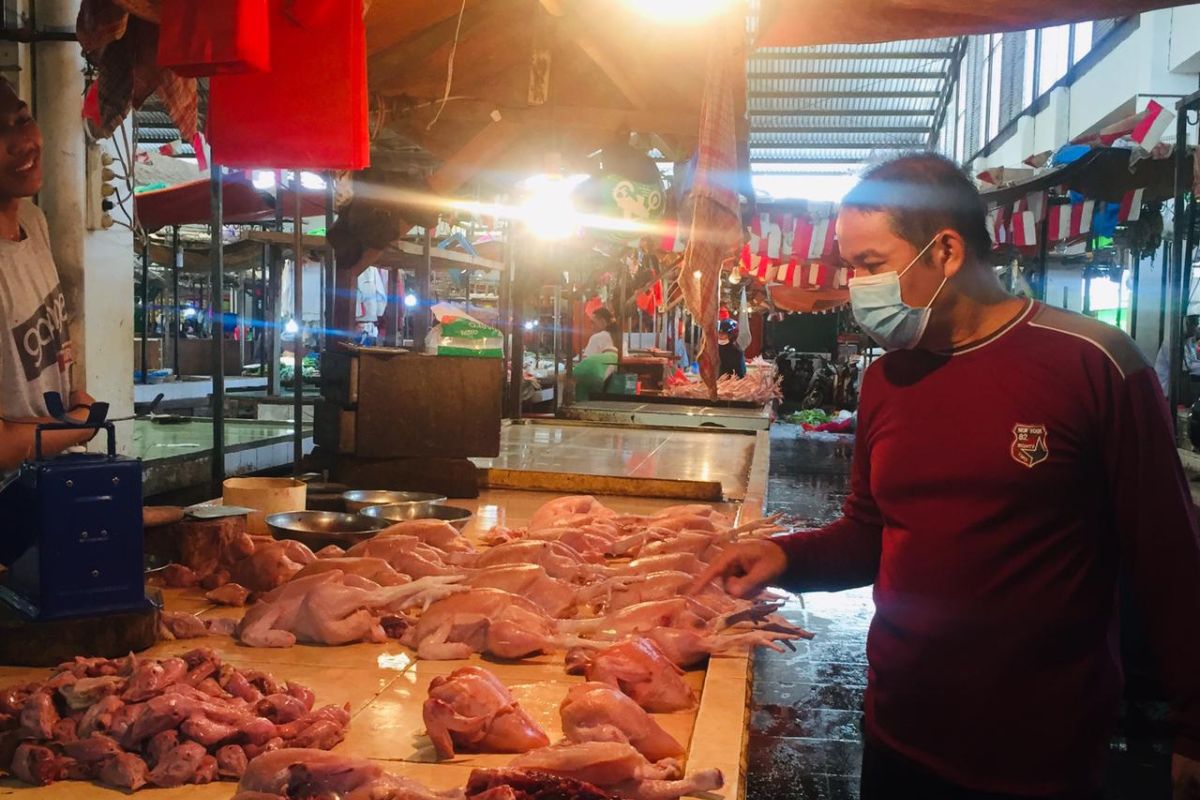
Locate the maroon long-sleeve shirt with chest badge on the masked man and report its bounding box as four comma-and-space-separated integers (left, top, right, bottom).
779, 303, 1200, 795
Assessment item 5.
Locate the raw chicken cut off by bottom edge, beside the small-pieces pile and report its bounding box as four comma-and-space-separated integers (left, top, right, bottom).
234, 748, 463, 800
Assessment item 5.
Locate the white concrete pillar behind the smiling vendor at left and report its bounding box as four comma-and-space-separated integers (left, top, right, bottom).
32, 0, 133, 450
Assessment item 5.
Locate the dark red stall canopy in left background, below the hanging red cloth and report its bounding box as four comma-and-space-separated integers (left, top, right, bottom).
134, 180, 325, 233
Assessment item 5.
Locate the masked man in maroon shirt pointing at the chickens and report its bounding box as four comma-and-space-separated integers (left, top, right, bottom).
697, 155, 1200, 800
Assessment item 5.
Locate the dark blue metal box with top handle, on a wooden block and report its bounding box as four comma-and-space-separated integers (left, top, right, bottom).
0, 393, 154, 622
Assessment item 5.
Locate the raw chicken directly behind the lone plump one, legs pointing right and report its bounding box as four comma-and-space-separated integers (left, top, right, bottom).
401, 589, 588, 661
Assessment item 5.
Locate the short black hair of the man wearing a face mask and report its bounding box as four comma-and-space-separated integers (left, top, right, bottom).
842, 152, 991, 261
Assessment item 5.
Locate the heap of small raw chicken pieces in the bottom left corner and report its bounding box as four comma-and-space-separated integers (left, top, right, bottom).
0, 649, 350, 792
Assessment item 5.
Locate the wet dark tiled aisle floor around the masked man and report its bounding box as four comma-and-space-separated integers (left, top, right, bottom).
746, 425, 1170, 800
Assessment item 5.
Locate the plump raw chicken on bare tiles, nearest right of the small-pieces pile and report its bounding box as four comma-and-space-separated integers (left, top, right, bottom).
422, 667, 550, 758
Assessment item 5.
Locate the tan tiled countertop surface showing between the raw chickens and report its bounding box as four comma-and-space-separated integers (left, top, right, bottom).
0, 462, 766, 800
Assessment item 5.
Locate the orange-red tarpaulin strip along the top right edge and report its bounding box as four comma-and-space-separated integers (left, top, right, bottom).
756, 0, 1188, 47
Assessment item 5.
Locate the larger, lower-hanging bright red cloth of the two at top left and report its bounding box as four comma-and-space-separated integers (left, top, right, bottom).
209, 0, 371, 169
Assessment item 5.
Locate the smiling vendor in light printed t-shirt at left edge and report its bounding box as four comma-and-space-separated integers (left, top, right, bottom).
0, 78, 94, 470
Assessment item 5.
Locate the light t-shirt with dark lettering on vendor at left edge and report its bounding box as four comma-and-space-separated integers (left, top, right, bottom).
0, 200, 71, 420
